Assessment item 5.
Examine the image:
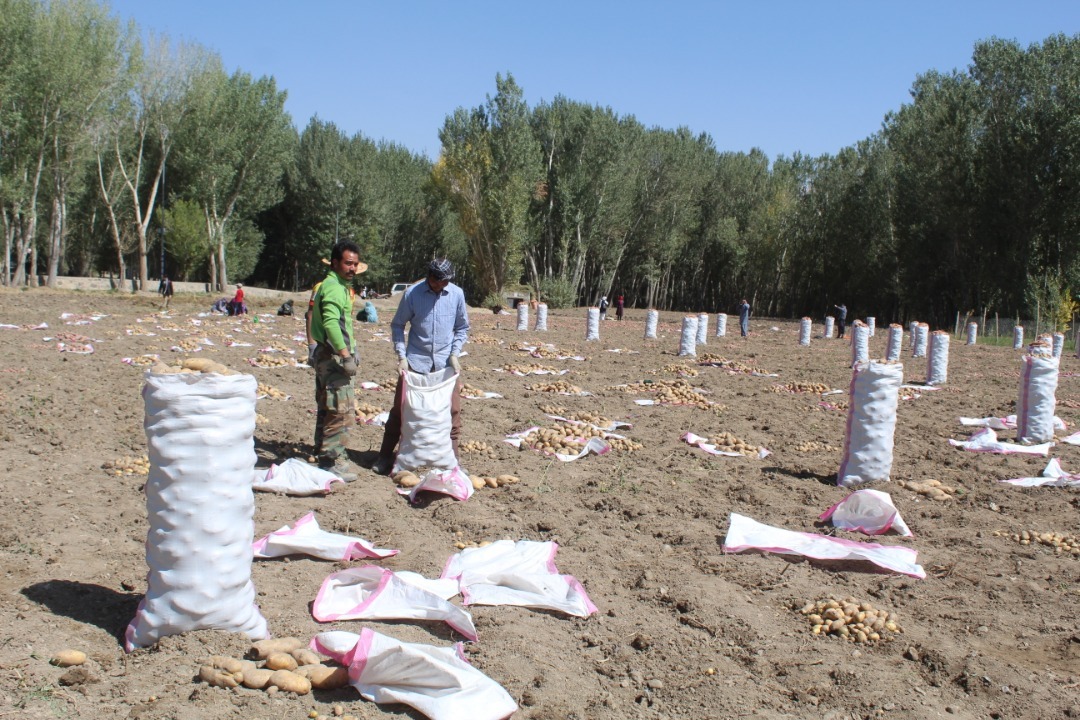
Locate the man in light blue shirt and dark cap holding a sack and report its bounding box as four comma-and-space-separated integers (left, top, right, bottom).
372, 259, 469, 475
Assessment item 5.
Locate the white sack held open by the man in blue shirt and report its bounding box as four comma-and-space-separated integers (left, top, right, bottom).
393, 367, 458, 473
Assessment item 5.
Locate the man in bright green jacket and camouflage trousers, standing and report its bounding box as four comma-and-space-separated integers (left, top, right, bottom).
311, 240, 367, 483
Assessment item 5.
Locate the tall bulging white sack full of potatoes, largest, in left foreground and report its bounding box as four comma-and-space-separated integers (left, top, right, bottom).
124, 371, 268, 652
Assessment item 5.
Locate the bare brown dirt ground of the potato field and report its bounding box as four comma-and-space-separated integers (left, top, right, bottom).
0, 289, 1080, 720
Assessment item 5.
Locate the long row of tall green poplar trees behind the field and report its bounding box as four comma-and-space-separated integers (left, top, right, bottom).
0, 0, 1080, 324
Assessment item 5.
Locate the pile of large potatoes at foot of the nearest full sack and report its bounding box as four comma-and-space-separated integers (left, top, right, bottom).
199, 638, 349, 695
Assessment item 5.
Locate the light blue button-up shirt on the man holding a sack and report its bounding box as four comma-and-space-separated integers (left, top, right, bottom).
390, 280, 469, 372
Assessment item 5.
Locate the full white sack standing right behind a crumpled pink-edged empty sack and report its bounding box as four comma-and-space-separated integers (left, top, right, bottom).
836, 363, 904, 488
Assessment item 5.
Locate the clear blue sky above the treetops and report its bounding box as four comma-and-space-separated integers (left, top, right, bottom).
108, 0, 1080, 159
